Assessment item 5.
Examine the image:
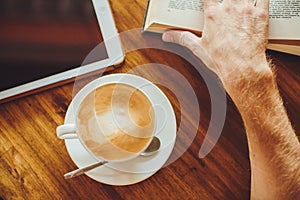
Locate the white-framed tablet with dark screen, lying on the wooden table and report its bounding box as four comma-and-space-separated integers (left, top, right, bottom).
0, 0, 124, 102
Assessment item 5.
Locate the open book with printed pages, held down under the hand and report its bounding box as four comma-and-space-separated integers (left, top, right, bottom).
143, 0, 300, 56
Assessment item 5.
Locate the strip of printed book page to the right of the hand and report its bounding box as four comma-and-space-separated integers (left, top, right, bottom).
269, 0, 300, 40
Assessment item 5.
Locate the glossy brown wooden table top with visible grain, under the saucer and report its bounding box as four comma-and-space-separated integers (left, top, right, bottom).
0, 0, 300, 199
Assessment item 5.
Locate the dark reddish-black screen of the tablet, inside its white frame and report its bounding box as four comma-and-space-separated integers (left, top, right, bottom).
0, 0, 108, 91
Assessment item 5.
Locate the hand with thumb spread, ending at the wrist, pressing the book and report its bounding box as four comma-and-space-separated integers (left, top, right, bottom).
163, 0, 271, 95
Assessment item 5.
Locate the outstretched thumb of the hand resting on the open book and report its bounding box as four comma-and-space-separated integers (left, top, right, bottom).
162, 31, 200, 50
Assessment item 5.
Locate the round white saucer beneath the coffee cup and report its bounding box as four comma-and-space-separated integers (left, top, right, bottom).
65, 74, 176, 185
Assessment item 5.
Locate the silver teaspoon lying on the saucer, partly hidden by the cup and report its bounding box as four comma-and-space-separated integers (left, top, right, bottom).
64, 136, 160, 179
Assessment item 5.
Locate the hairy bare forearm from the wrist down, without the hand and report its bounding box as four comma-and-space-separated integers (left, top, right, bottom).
225, 62, 300, 199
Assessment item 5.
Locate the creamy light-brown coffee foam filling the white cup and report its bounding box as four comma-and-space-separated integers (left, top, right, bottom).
77, 83, 155, 160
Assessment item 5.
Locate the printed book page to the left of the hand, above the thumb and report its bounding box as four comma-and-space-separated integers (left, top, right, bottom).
151, 0, 203, 30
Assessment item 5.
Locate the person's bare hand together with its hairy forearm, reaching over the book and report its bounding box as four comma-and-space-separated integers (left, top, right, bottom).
163, 0, 300, 199
